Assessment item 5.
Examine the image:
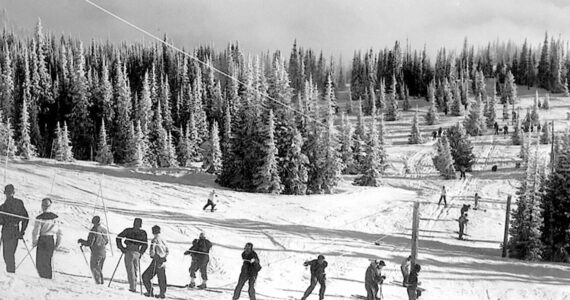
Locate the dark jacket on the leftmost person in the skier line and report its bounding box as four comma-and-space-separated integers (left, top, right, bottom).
0, 198, 29, 240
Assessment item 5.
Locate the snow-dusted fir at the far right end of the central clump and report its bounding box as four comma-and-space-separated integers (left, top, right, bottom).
354, 116, 381, 186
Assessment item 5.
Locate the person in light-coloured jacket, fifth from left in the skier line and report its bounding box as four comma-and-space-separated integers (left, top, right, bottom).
142, 225, 168, 299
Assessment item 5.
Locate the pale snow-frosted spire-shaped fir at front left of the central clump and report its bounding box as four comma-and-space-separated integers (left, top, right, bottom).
253, 110, 283, 194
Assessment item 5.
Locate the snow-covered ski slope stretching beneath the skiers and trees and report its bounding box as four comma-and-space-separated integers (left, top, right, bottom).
0, 86, 570, 300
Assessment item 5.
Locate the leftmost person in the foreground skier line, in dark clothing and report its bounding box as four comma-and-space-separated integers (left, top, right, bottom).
0, 184, 29, 273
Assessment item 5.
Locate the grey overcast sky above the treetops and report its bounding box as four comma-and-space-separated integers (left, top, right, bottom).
0, 0, 570, 62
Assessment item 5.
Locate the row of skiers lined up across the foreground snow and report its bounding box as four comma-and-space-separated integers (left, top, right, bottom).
0, 184, 419, 300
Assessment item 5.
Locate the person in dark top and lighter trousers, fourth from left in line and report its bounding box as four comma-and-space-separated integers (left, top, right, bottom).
116, 218, 148, 293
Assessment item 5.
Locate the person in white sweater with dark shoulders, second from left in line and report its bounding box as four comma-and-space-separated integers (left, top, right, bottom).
32, 198, 61, 279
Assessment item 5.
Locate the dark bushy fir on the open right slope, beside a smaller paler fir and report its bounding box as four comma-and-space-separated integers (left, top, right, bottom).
447, 122, 475, 171
